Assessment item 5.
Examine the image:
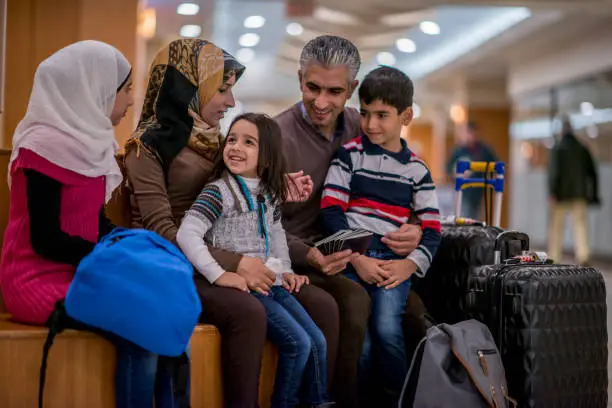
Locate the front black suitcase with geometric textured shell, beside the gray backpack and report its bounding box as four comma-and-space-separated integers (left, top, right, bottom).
467, 231, 608, 408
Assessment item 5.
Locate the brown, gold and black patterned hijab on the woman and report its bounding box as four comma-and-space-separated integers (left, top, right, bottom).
126, 39, 245, 168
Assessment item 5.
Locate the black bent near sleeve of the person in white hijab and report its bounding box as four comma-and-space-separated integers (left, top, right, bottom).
24, 169, 95, 266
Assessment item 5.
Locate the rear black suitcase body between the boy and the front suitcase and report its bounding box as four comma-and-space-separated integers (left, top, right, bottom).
412, 225, 503, 324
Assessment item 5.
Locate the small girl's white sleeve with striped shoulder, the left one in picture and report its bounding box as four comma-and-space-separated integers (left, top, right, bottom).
176, 185, 225, 283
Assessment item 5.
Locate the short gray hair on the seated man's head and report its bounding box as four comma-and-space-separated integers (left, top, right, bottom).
300, 35, 361, 81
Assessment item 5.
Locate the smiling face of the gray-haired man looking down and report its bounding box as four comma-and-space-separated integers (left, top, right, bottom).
299, 64, 358, 128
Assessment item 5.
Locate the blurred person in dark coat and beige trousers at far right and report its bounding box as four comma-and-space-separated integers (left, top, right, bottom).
548, 114, 599, 265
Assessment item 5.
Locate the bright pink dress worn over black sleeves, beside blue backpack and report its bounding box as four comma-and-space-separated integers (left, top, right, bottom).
0, 149, 105, 325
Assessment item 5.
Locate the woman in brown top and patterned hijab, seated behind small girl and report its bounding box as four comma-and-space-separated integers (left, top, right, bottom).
125, 39, 330, 408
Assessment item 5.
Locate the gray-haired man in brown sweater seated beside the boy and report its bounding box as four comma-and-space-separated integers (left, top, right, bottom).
276, 35, 420, 408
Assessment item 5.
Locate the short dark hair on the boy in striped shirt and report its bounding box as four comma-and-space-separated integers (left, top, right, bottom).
359, 67, 414, 113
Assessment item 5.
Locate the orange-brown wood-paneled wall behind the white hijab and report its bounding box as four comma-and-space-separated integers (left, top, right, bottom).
3, 0, 138, 147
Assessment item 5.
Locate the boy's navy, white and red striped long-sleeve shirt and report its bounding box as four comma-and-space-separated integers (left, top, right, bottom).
321, 136, 441, 276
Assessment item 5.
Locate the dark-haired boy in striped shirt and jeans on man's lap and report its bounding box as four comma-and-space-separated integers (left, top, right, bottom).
321, 67, 441, 407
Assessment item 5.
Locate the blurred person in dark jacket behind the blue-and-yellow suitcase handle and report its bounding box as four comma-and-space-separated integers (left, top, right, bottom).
446, 122, 498, 220
